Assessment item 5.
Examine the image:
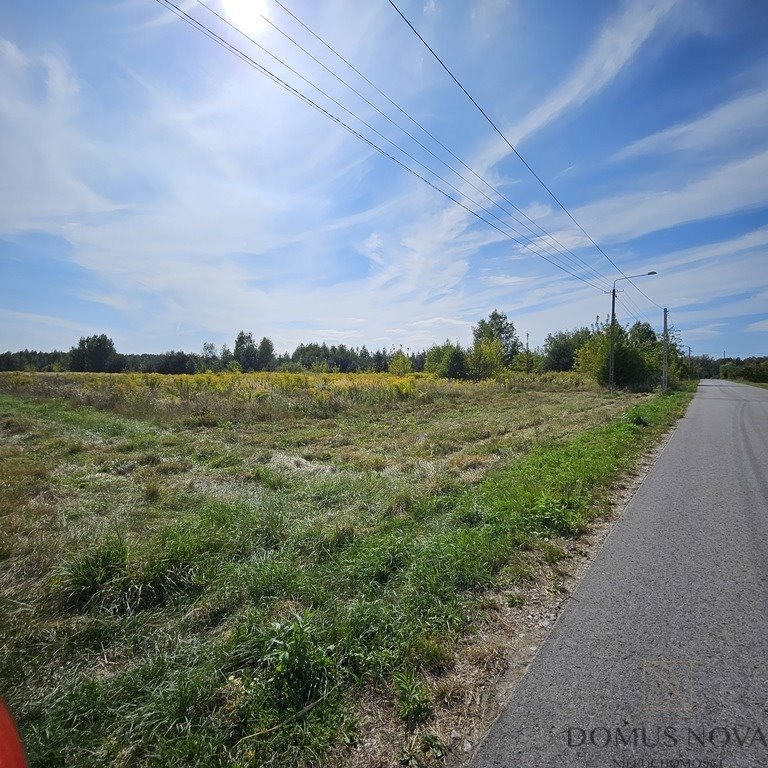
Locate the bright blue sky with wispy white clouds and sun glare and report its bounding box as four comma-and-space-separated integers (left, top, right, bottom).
0, 0, 768, 357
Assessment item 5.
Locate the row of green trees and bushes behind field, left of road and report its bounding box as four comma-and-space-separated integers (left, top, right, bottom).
0, 309, 696, 389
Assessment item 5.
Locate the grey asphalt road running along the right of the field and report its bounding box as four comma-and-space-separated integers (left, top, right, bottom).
471, 381, 768, 768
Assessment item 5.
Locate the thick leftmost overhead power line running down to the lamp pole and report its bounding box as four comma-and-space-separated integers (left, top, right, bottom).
157, 0, 602, 290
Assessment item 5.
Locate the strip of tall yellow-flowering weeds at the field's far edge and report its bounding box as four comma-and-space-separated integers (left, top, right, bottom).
0, 372, 592, 426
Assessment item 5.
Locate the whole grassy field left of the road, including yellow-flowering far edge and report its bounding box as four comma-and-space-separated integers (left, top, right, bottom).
0, 374, 689, 768
